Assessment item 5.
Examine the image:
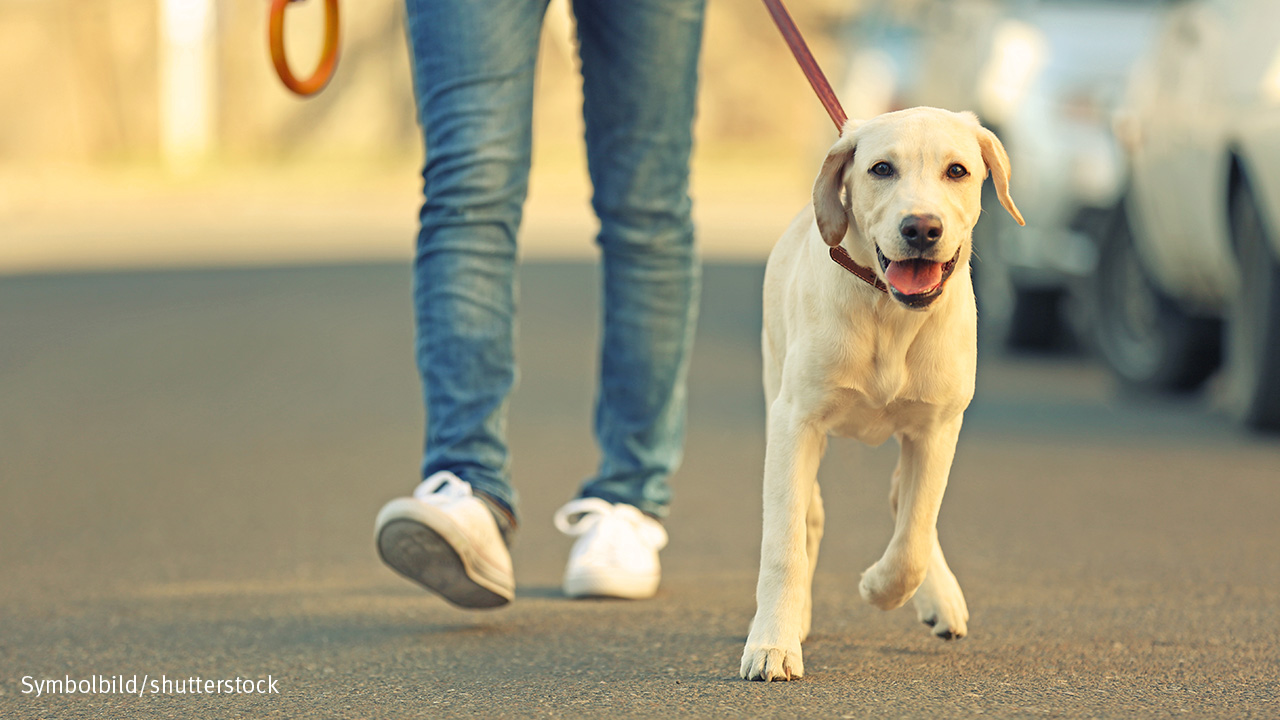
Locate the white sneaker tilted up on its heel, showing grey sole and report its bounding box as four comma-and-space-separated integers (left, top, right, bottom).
374, 471, 516, 609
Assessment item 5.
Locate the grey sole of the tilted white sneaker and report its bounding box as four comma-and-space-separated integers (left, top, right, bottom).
376, 501, 516, 610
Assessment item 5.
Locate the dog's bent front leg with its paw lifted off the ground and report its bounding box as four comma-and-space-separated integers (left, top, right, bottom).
858, 415, 961, 610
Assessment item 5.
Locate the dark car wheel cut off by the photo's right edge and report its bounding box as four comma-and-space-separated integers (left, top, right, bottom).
1226, 182, 1280, 430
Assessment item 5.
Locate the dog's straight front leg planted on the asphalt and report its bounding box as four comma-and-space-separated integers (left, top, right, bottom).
741, 398, 827, 682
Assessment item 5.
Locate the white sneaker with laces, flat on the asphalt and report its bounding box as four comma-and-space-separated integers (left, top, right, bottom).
556, 497, 667, 600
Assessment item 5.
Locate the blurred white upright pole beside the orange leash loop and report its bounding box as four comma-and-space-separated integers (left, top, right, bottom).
159, 0, 216, 174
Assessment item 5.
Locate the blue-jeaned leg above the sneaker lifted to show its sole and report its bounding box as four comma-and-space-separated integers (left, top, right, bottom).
406, 0, 547, 510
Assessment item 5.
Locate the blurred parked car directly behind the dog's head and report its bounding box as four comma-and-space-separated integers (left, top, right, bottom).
845, 0, 1165, 348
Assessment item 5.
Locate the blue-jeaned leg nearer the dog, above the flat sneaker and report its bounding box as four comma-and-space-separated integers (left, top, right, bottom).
573, 0, 704, 518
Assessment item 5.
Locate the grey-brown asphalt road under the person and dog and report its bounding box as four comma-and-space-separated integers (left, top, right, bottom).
0, 264, 1280, 719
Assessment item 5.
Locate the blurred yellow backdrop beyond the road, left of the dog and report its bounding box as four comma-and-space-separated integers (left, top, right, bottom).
0, 0, 851, 272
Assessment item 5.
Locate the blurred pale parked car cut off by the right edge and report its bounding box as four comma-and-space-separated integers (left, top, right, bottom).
1095, 0, 1280, 429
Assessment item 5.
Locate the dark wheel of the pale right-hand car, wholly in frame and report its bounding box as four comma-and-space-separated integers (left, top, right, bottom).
1094, 202, 1221, 392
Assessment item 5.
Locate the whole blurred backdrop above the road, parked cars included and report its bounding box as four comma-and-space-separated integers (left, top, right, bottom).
0, 0, 1280, 429
